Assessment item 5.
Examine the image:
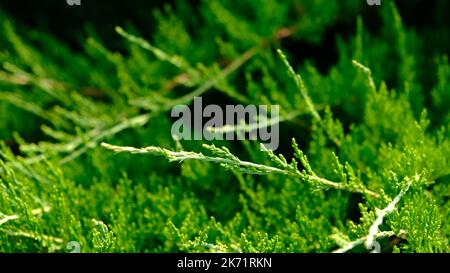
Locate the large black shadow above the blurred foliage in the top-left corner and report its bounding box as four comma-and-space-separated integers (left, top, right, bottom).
0, 0, 193, 49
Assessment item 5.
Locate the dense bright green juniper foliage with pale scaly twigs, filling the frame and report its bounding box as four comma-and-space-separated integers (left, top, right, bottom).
0, 0, 450, 252
